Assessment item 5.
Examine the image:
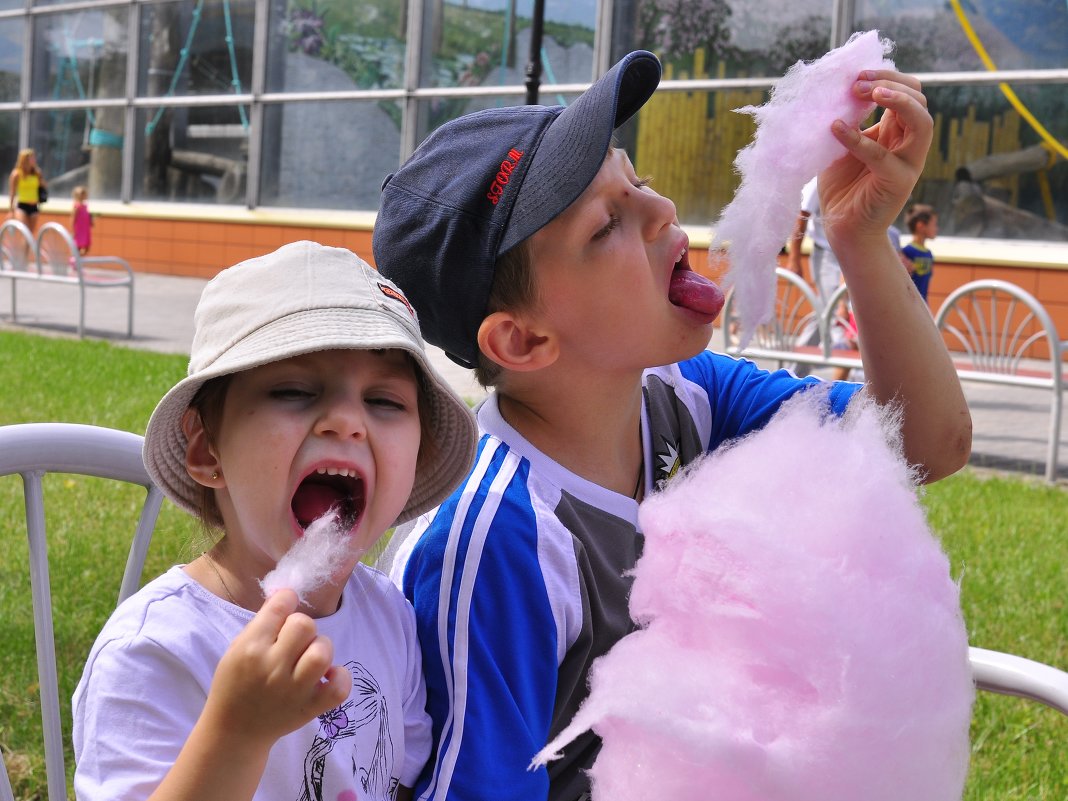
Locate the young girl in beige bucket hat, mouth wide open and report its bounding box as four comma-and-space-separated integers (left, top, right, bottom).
74, 242, 475, 801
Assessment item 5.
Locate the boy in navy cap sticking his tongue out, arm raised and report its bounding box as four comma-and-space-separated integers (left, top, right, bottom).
374, 51, 971, 801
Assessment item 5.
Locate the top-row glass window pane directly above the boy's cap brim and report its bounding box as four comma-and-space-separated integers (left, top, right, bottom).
612, 0, 832, 78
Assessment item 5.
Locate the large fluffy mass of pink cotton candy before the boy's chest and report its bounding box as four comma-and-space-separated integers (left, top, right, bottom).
535, 392, 974, 801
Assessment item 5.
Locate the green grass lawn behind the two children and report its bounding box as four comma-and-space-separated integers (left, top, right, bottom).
0, 331, 1068, 801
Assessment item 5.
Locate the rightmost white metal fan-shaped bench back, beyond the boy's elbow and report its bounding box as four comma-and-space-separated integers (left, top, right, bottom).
935, 279, 1065, 482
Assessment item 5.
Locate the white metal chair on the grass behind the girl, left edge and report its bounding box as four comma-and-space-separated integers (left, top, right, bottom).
0, 423, 163, 801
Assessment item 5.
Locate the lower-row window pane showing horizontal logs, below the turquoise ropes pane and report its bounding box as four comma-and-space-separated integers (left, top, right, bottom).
134, 106, 249, 204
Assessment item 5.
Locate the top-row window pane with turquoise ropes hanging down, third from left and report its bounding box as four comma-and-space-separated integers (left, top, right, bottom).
138, 0, 255, 97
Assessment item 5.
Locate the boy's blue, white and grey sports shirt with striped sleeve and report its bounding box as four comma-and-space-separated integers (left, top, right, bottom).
393, 351, 860, 801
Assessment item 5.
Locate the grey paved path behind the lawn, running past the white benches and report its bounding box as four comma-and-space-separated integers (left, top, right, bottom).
0, 273, 1068, 486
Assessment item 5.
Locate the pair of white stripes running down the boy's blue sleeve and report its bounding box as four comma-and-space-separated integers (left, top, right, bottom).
420, 440, 520, 801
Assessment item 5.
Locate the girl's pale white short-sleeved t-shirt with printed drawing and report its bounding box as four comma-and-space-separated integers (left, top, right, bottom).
74, 565, 431, 801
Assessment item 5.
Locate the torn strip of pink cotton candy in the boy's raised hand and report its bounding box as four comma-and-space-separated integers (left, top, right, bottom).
713, 31, 894, 345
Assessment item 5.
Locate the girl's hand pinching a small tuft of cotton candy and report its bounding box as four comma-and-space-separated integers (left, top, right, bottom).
198, 590, 352, 747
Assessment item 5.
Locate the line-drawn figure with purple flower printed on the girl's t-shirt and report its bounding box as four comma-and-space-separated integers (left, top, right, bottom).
298, 662, 397, 801
